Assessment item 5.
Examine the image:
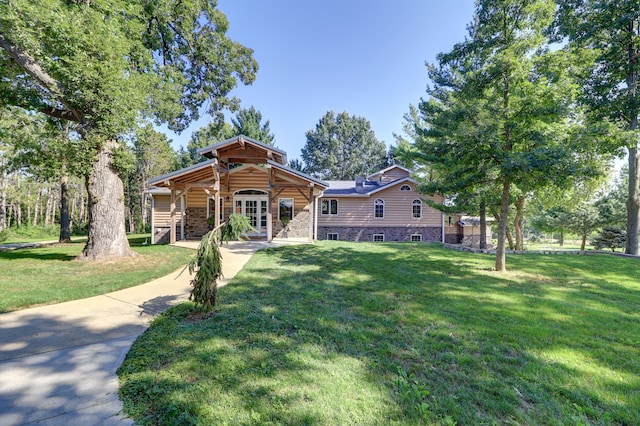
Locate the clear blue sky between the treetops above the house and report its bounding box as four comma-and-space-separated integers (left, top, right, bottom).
166, 0, 474, 159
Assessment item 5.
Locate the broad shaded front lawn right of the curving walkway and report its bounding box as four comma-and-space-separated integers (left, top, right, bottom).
119, 242, 640, 425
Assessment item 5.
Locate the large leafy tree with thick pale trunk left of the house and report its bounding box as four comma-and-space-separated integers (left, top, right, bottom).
0, 0, 257, 259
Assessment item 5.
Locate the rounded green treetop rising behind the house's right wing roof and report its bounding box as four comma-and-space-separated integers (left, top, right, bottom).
302, 111, 387, 180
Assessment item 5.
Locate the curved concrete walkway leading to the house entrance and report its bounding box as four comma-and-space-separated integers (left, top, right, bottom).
0, 240, 302, 426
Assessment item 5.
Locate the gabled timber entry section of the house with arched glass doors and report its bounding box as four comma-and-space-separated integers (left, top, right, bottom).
149, 136, 328, 243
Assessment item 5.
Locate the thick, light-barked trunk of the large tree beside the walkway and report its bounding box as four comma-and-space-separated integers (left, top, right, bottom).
78, 139, 136, 260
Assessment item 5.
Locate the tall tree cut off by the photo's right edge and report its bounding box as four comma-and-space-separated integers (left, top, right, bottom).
556, 0, 640, 255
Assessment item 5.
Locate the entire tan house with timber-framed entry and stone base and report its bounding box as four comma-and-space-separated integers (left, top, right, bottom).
148, 136, 490, 243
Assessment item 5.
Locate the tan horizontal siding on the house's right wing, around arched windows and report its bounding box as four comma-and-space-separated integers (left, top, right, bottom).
318, 184, 443, 227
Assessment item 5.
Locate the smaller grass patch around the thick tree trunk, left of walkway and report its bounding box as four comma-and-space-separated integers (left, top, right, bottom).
0, 236, 195, 313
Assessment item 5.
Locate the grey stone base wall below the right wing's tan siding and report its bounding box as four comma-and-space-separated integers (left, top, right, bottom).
318, 226, 442, 242
